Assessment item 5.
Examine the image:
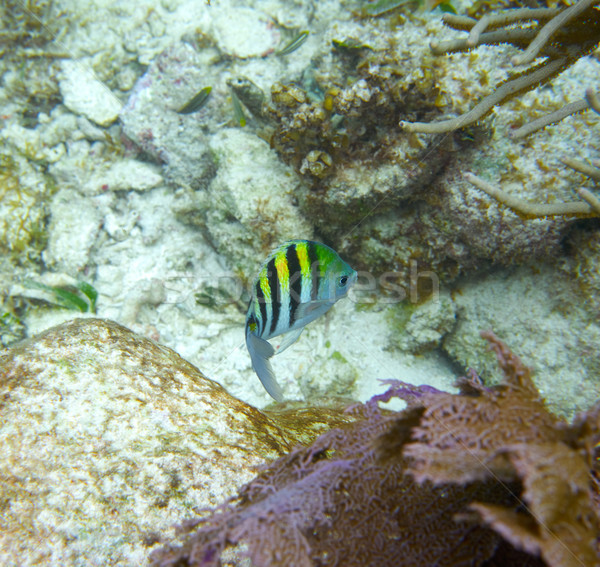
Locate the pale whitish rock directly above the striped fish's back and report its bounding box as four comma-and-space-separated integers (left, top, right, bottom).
177, 128, 312, 277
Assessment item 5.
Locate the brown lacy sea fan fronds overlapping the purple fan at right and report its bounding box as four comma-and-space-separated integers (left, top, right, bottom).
383, 333, 600, 567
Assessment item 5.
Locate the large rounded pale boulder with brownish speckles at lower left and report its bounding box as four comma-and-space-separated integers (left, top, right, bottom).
0, 319, 347, 565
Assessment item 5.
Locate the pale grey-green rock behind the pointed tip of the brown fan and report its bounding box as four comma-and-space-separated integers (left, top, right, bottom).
442, 264, 600, 418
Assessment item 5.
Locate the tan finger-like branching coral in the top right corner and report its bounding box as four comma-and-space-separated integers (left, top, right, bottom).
400, 0, 600, 137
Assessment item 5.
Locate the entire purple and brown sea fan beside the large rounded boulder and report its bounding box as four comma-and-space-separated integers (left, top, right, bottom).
152, 333, 600, 567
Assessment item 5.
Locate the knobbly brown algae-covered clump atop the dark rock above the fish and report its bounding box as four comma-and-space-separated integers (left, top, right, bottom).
266, 53, 439, 183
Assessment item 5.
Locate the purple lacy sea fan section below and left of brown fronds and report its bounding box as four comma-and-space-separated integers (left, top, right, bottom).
153, 400, 506, 567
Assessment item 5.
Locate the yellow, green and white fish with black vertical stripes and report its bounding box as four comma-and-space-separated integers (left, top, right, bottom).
246, 240, 357, 402
